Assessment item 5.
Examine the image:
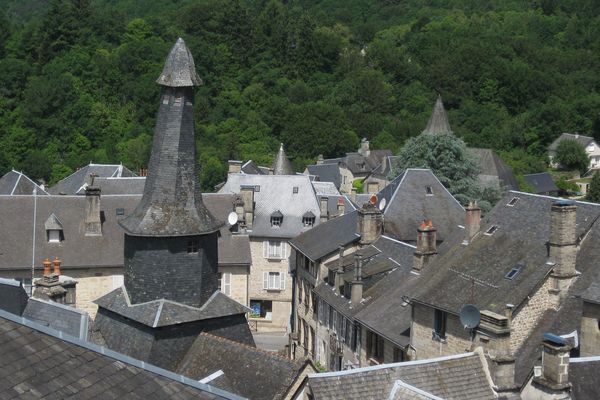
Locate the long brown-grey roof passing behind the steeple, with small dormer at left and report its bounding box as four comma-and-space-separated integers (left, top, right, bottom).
0, 188, 251, 270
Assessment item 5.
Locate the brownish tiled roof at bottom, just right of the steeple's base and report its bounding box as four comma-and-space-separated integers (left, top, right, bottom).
176, 333, 315, 400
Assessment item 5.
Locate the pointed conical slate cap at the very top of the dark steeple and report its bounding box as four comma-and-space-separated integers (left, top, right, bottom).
156, 38, 202, 87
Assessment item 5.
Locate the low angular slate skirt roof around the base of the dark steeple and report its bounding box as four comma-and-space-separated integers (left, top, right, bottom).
95, 286, 251, 328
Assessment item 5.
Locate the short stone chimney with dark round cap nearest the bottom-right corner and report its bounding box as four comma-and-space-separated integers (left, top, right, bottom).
533, 333, 573, 398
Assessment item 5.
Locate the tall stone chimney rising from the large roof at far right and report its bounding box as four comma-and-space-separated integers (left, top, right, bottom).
548, 200, 577, 305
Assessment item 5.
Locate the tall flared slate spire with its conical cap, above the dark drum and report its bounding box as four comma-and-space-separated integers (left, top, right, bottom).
121, 38, 219, 237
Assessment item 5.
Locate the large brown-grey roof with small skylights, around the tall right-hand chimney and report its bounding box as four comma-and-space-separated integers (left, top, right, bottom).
414, 191, 600, 314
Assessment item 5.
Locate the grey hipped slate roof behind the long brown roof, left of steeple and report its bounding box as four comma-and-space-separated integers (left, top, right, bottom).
48, 163, 135, 195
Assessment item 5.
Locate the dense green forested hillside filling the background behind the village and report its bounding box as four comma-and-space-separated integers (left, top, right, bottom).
0, 0, 600, 190
